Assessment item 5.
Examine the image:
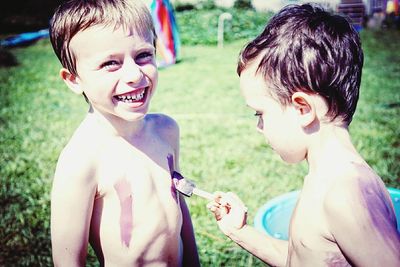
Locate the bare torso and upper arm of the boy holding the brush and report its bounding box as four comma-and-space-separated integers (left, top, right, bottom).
287, 148, 399, 266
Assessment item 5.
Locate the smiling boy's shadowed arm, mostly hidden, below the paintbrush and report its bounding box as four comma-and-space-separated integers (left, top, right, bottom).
179, 194, 200, 267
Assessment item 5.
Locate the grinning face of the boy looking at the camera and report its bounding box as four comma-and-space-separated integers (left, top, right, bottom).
67, 25, 158, 121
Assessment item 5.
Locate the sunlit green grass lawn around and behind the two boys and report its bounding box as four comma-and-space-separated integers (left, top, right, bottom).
0, 7, 400, 266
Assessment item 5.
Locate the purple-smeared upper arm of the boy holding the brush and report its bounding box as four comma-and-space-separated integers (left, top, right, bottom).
325, 184, 400, 267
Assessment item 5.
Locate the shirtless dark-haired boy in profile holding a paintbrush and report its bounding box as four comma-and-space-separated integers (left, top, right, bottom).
208, 4, 400, 267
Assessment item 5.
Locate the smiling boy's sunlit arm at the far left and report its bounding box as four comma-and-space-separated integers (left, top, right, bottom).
51, 150, 96, 267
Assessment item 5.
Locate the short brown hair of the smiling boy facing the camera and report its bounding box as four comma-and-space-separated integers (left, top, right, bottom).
50, 0, 156, 75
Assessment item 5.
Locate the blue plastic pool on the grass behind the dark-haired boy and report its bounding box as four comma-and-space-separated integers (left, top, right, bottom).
254, 187, 400, 240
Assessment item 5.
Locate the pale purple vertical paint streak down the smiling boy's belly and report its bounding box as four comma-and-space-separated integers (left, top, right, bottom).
114, 180, 133, 247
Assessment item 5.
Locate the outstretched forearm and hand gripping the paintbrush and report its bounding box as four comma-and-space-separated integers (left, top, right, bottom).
207, 192, 289, 266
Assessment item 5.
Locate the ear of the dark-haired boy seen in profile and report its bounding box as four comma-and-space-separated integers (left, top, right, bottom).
291, 92, 316, 127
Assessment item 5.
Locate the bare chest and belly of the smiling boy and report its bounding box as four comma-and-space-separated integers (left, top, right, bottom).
91, 139, 182, 258
